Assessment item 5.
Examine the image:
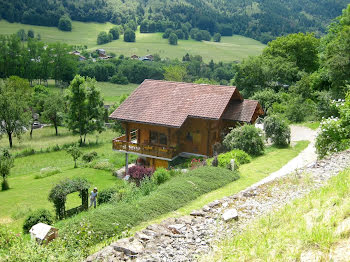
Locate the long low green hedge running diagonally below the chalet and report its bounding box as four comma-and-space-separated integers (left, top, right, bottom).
61, 167, 239, 242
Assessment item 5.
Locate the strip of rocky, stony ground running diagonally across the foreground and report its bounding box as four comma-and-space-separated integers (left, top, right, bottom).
87, 145, 350, 262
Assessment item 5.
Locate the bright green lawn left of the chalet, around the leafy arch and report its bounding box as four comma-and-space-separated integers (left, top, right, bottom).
0, 128, 134, 231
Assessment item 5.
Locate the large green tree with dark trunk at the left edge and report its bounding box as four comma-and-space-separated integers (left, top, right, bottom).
0, 76, 31, 148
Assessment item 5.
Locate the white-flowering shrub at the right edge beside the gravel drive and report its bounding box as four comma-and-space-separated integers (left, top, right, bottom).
315, 118, 349, 158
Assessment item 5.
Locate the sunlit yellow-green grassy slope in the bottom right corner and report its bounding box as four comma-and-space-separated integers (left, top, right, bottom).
204, 170, 350, 261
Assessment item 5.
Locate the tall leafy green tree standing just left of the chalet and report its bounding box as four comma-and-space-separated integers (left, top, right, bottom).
66, 75, 105, 145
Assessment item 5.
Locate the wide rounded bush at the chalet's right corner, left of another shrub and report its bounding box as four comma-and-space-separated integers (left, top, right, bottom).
223, 125, 265, 155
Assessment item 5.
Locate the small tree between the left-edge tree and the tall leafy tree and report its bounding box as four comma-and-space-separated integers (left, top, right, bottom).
42, 92, 65, 136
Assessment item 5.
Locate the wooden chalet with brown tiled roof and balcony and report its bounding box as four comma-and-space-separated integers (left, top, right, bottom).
110, 79, 263, 173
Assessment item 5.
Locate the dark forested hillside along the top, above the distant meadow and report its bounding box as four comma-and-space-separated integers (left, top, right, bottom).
0, 0, 348, 42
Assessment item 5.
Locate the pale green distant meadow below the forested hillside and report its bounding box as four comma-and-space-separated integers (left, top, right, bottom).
0, 20, 265, 62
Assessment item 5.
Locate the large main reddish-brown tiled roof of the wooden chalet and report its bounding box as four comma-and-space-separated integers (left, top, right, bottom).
110, 79, 262, 128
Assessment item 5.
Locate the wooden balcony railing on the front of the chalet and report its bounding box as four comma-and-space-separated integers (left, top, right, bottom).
113, 135, 177, 159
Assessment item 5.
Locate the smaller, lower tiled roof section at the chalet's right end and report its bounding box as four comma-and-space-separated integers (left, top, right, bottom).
222, 99, 262, 122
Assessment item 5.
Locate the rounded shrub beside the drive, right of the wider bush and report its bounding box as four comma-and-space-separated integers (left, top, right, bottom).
264, 115, 290, 146
